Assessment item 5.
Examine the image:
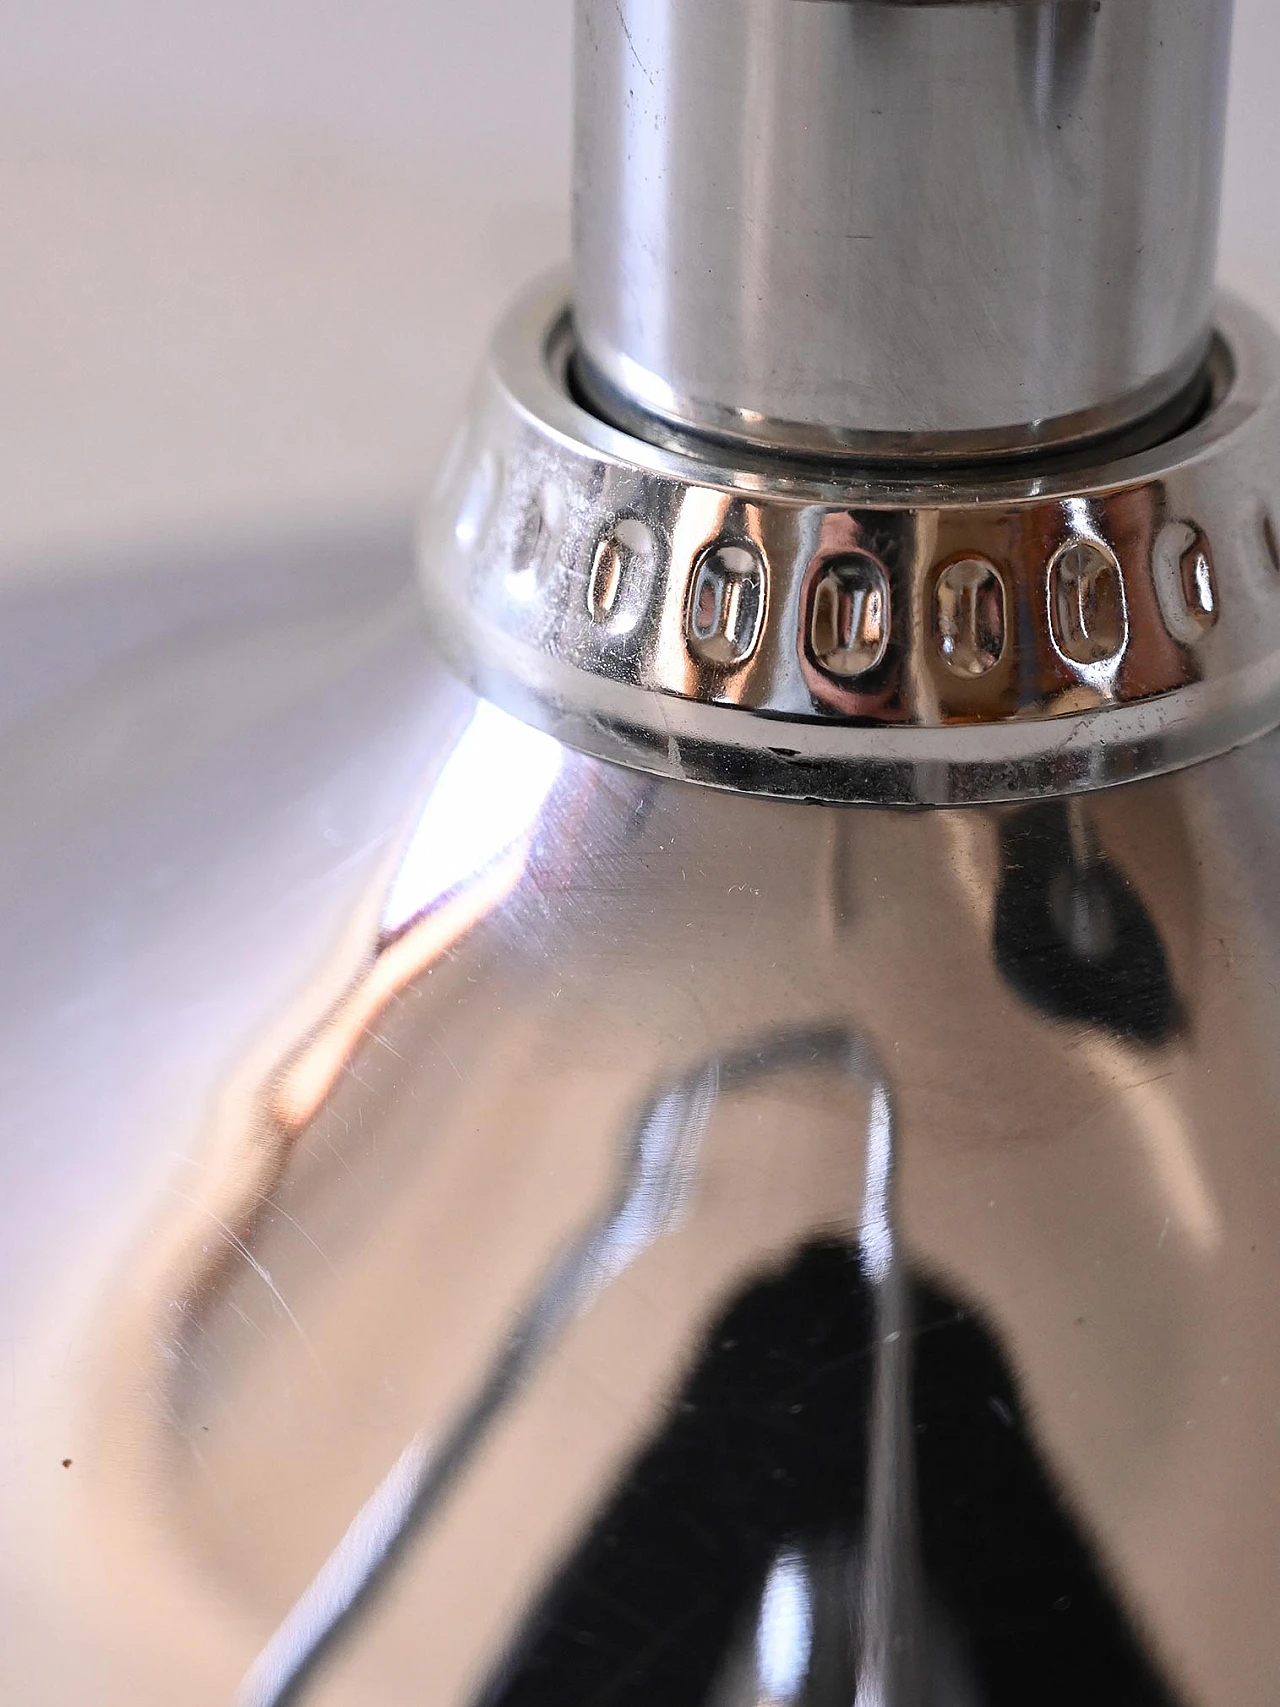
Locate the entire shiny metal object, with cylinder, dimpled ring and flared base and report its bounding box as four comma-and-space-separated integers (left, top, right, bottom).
10, 0, 1280, 1707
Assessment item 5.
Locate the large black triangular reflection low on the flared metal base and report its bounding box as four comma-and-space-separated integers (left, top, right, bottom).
481, 1239, 1172, 1707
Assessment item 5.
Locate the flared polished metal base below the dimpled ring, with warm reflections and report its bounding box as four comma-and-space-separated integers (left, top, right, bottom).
0, 524, 1280, 1707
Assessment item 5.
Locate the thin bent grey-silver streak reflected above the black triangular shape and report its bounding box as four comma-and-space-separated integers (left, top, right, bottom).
237, 1029, 893, 1707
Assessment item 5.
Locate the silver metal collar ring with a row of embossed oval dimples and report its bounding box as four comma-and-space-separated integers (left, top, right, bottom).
422, 278, 1280, 804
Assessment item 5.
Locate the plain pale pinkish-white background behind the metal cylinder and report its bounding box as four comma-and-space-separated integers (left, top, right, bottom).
0, 0, 1280, 567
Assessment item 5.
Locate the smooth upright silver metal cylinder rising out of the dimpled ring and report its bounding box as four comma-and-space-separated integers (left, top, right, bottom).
573, 0, 1231, 457
